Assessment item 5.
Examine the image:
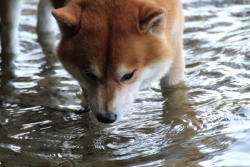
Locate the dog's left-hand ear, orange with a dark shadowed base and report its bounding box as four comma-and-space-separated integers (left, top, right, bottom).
52, 3, 82, 36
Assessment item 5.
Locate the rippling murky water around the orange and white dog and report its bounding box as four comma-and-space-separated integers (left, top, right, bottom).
0, 0, 250, 167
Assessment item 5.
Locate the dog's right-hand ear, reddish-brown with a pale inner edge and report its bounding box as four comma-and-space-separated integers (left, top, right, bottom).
139, 4, 166, 35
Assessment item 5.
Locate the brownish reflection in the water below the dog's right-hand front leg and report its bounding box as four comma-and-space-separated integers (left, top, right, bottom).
162, 84, 202, 138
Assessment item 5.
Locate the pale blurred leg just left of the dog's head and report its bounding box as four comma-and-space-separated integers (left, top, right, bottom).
37, 0, 56, 52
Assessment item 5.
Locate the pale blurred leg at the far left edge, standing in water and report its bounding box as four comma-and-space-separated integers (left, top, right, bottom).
0, 0, 23, 55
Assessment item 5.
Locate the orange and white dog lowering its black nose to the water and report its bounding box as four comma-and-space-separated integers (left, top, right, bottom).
0, 0, 185, 123
